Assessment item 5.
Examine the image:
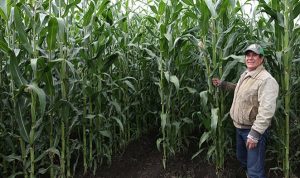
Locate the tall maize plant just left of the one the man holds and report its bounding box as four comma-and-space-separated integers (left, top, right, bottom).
145, 0, 203, 167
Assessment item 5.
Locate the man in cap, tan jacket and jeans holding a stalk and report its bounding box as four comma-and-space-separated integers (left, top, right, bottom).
212, 44, 279, 178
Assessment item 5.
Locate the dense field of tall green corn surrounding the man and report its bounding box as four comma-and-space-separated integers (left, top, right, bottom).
0, 0, 300, 178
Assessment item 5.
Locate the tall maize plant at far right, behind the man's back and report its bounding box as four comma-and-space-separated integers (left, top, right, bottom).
260, 0, 300, 177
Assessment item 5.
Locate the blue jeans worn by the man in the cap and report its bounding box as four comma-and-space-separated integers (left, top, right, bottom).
236, 129, 268, 178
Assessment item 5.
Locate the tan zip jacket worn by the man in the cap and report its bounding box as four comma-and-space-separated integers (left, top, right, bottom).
230, 65, 279, 137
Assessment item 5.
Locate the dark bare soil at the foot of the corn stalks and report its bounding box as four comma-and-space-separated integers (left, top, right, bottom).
78, 129, 297, 178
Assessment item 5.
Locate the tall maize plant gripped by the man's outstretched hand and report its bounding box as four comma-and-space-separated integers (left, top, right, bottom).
193, 1, 247, 172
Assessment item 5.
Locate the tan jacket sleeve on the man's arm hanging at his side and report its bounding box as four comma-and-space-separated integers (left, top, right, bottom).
249, 78, 279, 140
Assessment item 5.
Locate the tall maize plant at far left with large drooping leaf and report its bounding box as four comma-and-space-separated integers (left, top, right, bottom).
1, 2, 46, 177
